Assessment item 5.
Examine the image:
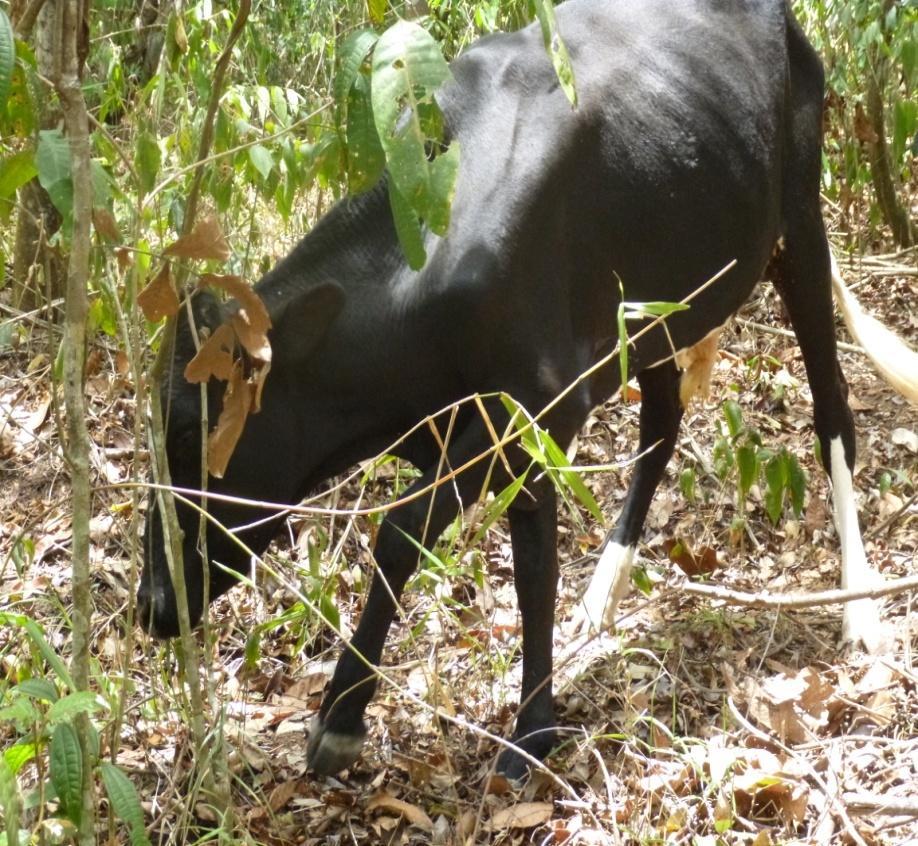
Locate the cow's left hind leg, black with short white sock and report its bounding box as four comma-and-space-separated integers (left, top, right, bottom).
572, 361, 682, 633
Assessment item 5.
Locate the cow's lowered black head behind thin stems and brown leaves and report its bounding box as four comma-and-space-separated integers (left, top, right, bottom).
137, 282, 344, 637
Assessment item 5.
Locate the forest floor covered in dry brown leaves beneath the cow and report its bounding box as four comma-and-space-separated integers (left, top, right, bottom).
0, 235, 918, 846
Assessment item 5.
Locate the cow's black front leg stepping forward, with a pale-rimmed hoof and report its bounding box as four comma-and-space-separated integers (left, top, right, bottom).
307, 407, 510, 775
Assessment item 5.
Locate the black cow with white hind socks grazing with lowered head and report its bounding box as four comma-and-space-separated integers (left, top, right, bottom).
139, 0, 908, 776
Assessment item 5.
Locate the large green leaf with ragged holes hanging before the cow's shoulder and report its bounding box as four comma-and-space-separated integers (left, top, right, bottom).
372, 21, 457, 246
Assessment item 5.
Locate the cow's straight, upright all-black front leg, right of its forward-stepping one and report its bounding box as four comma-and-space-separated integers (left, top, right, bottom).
497, 485, 558, 779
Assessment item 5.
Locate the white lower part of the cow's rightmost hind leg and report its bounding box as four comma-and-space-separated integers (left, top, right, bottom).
830, 437, 888, 652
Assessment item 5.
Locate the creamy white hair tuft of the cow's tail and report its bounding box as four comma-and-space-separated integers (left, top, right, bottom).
832, 256, 918, 405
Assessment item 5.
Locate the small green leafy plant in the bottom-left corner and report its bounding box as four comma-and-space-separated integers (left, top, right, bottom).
0, 612, 149, 846
